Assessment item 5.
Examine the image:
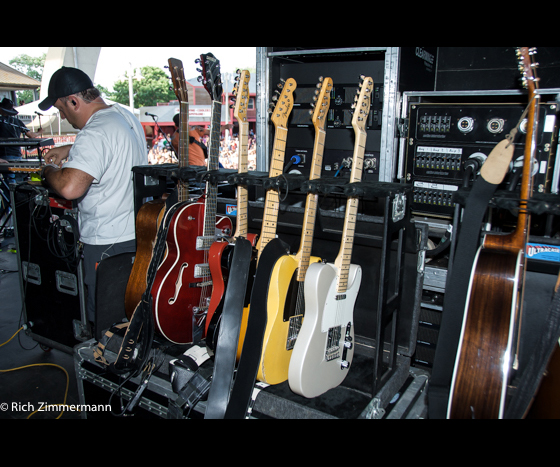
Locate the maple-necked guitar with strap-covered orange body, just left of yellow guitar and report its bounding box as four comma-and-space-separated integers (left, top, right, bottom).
237, 78, 297, 360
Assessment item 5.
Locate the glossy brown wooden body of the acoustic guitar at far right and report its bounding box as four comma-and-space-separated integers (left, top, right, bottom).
448, 248, 523, 419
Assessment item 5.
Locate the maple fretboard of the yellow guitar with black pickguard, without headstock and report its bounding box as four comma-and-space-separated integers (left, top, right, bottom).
296, 129, 326, 282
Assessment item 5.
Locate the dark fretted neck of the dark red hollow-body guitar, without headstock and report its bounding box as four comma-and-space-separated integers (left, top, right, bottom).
204, 101, 222, 239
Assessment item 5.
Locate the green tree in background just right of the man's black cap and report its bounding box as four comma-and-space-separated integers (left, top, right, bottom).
107, 66, 175, 109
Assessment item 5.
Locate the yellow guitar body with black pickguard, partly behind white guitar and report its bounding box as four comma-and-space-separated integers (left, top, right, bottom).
257, 256, 321, 385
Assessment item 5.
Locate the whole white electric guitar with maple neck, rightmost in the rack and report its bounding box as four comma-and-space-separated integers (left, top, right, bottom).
288, 77, 373, 398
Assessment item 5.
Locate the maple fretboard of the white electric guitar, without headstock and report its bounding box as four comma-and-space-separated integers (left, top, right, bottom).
335, 130, 367, 294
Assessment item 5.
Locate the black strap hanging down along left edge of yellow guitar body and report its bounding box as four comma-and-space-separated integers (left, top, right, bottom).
224, 238, 289, 419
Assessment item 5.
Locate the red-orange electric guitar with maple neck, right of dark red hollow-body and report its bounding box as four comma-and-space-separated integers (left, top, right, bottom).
206, 70, 257, 351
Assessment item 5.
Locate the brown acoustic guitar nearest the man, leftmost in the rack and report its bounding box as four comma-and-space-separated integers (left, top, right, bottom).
125, 58, 189, 320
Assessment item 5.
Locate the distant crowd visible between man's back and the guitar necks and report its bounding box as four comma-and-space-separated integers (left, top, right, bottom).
148, 130, 257, 170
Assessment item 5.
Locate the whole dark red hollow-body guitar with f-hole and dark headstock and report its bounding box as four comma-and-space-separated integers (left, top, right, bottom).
152, 54, 232, 344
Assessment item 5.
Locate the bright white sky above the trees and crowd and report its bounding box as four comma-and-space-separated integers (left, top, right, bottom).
0, 47, 256, 89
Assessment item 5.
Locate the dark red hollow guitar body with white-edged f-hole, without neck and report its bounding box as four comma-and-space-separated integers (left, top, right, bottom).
152, 203, 232, 344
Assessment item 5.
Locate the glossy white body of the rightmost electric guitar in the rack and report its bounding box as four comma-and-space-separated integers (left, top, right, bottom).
288, 263, 362, 398
